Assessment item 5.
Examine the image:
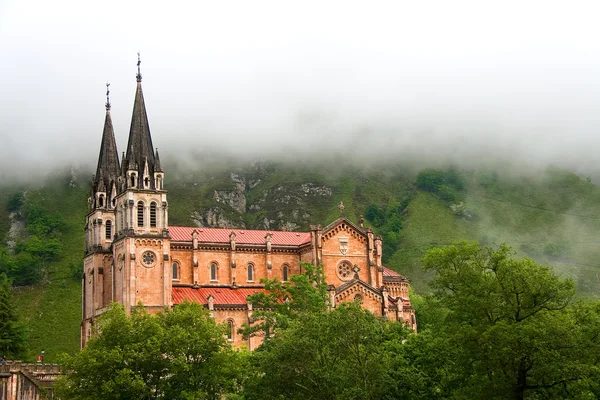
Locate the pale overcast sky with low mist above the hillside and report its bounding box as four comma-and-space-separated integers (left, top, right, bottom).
0, 0, 600, 177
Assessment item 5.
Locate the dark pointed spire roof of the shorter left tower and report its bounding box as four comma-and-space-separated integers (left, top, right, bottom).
94, 103, 120, 191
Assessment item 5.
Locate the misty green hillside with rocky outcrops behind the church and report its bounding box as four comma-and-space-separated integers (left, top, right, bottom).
0, 163, 600, 361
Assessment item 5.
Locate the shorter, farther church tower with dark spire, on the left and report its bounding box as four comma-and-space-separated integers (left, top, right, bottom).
81, 83, 121, 345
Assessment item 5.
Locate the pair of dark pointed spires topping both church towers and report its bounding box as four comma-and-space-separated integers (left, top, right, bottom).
92, 53, 162, 200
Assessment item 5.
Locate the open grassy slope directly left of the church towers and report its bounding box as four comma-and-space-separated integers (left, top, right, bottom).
2, 175, 88, 362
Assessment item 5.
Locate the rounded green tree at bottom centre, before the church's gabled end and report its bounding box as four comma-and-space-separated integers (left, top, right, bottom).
245, 303, 408, 399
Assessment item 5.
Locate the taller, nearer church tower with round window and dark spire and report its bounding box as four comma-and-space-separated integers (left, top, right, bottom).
112, 54, 172, 313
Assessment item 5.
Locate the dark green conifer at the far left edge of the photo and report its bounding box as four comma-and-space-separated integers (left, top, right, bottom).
0, 273, 25, 358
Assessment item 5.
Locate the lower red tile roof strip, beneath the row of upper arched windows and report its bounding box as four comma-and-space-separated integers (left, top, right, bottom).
171, 287, 266, 305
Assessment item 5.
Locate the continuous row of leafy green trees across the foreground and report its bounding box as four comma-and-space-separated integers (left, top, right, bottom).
57, 242, 600, 400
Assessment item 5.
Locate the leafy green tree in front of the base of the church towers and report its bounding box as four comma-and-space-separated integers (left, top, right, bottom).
56, 303, 246, 399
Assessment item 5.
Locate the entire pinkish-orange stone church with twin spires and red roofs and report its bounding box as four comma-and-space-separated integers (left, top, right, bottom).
81, 60, 416, 350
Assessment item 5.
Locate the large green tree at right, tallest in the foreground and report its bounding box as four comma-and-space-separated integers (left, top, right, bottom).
423, 242, 600, 399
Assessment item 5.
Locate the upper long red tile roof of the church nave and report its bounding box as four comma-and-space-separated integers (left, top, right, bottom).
169, 226, 310, 246
